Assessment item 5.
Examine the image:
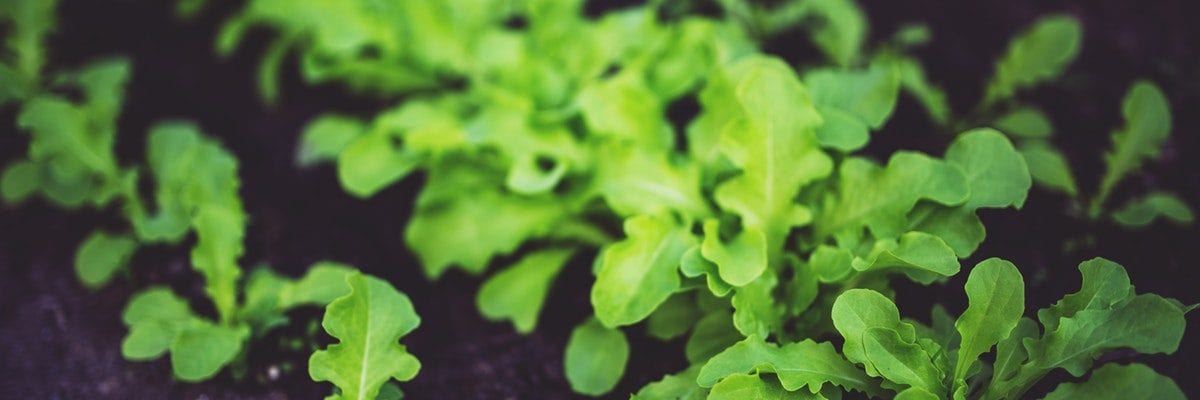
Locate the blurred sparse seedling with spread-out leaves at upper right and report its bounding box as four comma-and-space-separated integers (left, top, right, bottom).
913, 14, 1194, 228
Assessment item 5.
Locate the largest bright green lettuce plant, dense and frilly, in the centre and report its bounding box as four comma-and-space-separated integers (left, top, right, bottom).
285, 0, 1030, 395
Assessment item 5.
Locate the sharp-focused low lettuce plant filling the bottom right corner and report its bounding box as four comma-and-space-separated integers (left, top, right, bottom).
696, 258, 1194, 399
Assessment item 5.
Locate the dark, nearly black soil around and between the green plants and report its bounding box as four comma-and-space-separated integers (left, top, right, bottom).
0, 0, 1200, 399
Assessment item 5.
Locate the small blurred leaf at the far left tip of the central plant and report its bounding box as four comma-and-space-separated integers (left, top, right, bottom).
296, 114, 367, 167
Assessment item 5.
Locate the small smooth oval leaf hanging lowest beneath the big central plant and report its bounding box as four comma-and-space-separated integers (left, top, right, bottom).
563, 320, 629, 396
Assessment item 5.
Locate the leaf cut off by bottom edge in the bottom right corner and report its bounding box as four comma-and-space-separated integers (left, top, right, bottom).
1045, 364, 1187, 400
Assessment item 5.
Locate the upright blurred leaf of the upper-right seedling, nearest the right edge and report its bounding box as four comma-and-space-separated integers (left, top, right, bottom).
1088, 80, 1171, 213
